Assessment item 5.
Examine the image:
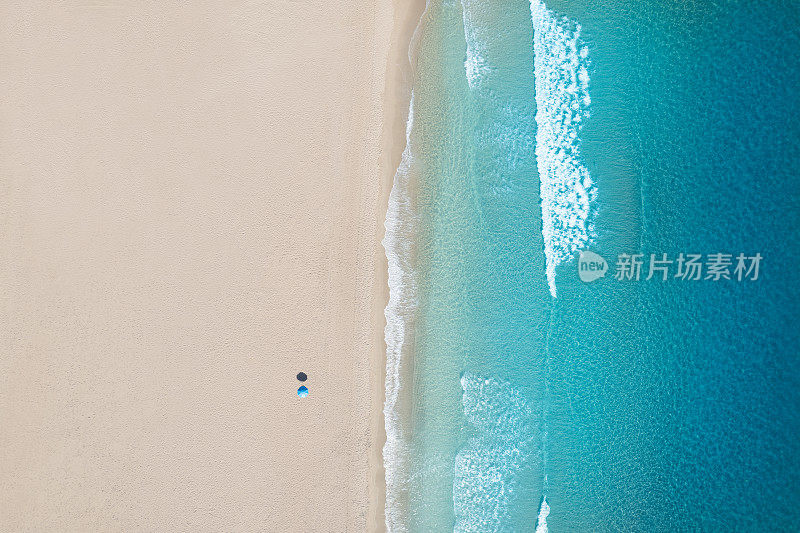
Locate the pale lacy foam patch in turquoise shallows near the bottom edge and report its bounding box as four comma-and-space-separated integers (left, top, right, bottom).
453, 374, 537, 533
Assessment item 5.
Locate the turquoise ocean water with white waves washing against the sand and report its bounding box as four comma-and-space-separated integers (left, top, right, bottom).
384, 0, 800, 532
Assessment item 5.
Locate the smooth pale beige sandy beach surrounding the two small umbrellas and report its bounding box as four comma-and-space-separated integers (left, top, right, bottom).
0, 0, 422, 532
